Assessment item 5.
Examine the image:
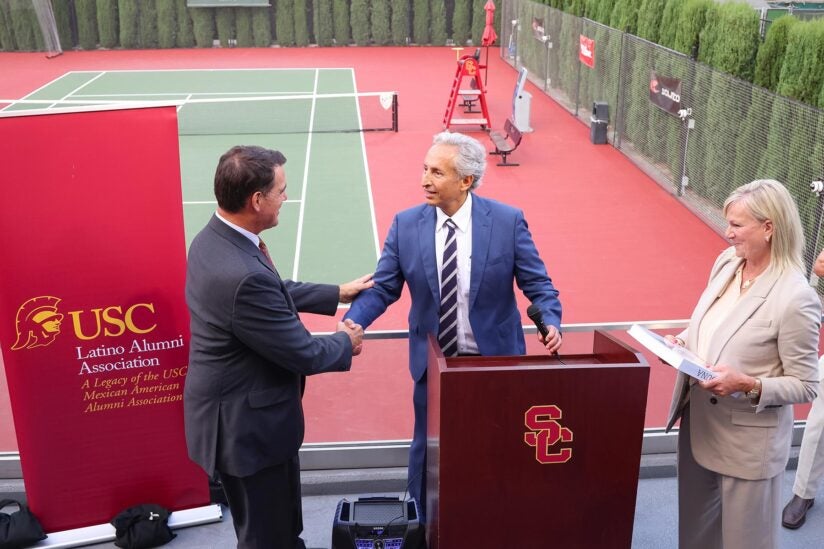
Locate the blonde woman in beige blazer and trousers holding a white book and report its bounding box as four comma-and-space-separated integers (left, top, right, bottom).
667, 180, 821, 549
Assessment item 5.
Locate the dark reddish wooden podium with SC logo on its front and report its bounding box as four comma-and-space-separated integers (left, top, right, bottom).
426, 331, 649, 549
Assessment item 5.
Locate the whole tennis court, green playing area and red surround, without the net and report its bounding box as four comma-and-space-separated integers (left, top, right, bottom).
0, 47, 806, 444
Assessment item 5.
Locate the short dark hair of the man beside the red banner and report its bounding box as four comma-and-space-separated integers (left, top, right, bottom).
215, 145, 286, 213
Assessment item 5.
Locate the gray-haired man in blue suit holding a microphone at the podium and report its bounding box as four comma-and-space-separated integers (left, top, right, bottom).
345, 132, 561, 515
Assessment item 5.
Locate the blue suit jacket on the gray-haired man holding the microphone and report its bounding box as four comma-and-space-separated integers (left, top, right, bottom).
346, 194, 561, 381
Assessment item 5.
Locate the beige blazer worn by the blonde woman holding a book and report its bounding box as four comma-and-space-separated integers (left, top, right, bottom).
667, 247, 821, 480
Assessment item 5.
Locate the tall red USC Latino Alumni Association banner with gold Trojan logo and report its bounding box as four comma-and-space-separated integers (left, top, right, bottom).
0, 107, 209, 532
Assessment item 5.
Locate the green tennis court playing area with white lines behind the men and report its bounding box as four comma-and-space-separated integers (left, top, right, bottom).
9, 69, 384, 283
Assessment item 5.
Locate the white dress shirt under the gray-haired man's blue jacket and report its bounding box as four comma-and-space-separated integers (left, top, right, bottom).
435, 192, 478, 354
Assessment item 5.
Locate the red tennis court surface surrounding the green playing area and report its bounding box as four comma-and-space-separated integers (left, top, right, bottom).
0, 47, 807, 451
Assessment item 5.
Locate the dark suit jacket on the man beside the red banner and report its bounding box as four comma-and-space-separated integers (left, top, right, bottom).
183, 212, 352, 477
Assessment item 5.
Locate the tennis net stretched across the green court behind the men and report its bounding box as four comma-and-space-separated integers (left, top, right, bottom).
178, 92, 398, 135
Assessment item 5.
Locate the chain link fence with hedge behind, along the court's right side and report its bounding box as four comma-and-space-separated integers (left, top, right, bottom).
500, 0, 824, 295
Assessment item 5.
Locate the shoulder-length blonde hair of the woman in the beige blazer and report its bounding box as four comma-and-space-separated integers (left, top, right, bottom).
724, 179, 804, 272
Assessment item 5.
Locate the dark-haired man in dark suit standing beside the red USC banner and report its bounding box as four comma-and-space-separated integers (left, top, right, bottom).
183, 146, 371, 549
